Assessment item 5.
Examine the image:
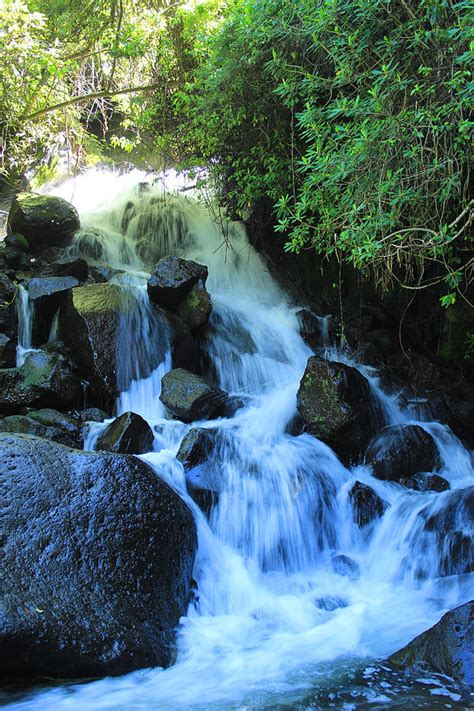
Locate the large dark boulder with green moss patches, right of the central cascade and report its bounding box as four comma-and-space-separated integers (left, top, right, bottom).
297, 356, 376, 468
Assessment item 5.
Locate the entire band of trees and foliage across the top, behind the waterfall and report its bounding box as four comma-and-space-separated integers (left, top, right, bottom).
0, 0, 474, 363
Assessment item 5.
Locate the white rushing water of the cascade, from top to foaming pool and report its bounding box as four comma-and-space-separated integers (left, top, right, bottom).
8, 173, 474, 711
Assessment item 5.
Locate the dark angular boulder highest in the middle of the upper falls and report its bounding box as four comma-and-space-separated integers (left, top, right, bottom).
147, 257, 208, 311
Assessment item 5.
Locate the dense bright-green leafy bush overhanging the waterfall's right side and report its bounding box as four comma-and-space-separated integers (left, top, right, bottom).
175, 0, 474, 305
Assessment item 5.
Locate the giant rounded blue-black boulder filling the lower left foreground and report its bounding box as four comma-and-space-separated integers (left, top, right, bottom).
0, 434, 196, 678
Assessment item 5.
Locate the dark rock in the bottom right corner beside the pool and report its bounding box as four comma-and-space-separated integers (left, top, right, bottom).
389, 600, 474, 695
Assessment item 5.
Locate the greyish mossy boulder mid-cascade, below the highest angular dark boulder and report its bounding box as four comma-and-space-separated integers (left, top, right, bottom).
160, 368, 227, 422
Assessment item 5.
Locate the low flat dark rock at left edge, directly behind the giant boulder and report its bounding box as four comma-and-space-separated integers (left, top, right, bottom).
0, 408, 83, 449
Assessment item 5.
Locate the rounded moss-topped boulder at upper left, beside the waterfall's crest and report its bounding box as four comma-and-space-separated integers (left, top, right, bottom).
8, 192, 80, 251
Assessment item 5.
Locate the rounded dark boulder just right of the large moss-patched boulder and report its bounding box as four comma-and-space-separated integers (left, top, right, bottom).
366, 425, 441, 486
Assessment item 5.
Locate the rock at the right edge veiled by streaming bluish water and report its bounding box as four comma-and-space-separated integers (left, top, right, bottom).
424, 486, 474, 576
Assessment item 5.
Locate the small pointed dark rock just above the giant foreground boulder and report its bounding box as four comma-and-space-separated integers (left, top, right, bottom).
96, 412, 153, 454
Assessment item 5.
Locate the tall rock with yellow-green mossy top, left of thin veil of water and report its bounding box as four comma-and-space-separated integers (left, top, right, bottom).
59, 284, 127, 404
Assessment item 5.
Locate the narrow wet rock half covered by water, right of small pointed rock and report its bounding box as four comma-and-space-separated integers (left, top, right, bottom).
176, 427, 221, 516
